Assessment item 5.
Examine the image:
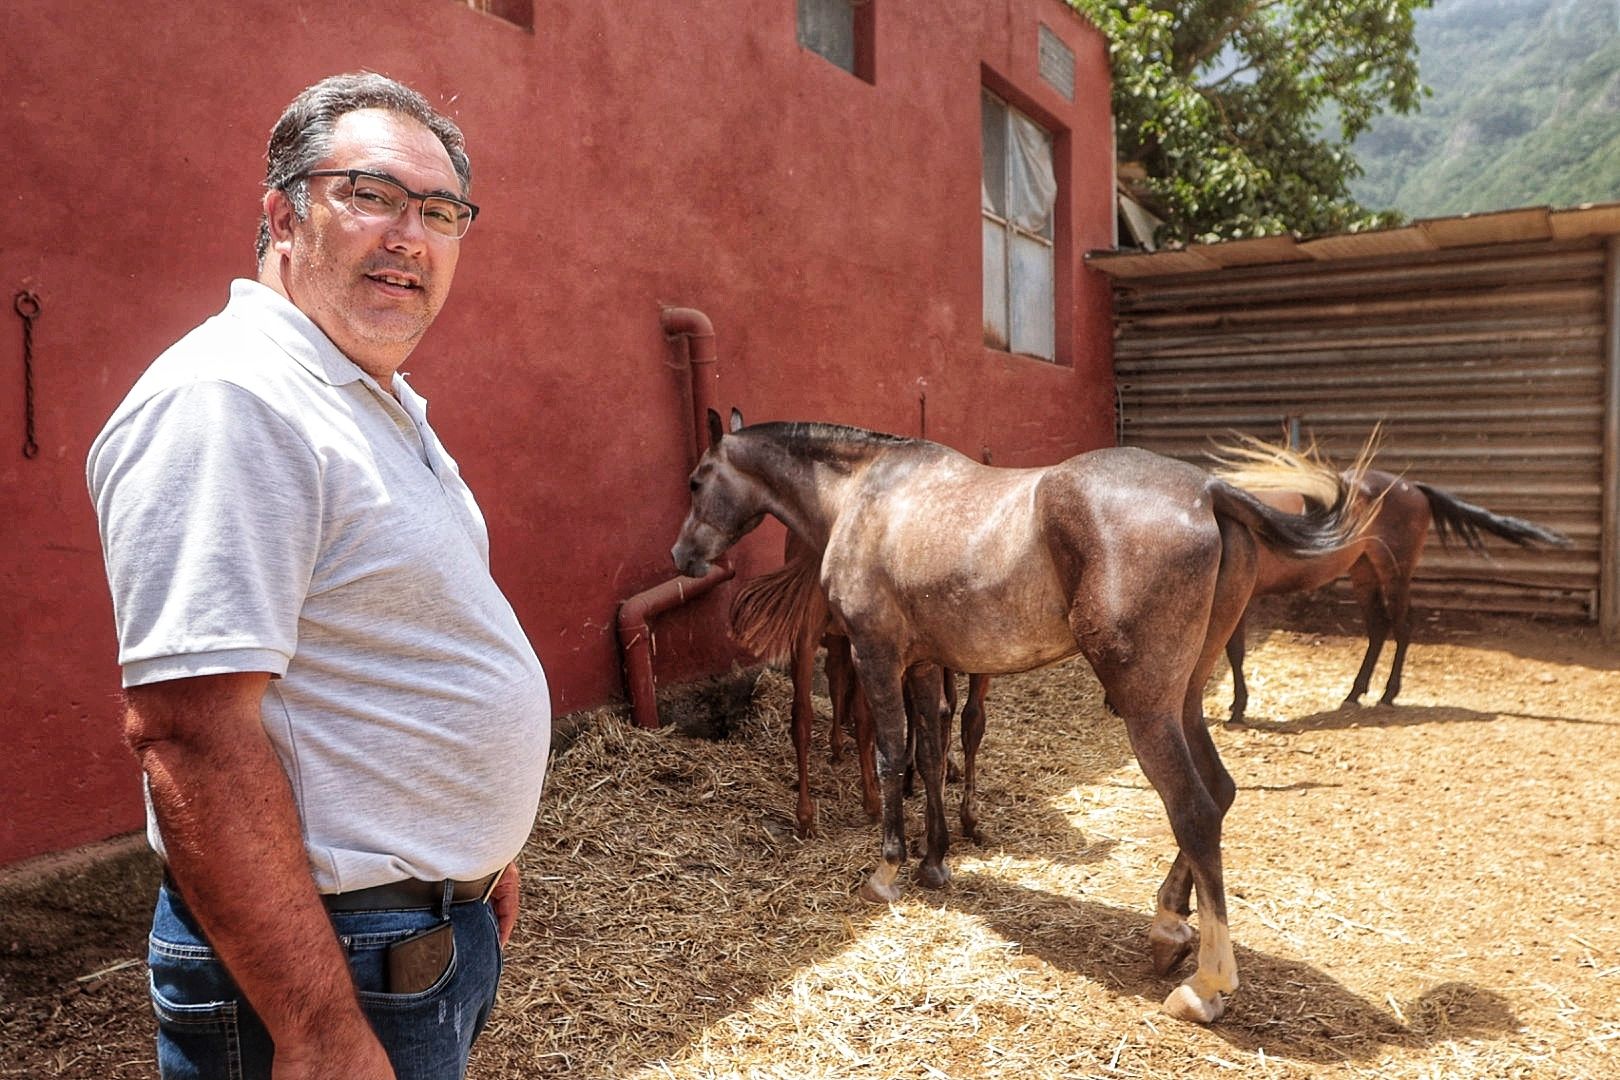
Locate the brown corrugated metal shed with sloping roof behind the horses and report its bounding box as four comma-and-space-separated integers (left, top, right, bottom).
1087, 204, 1620, 635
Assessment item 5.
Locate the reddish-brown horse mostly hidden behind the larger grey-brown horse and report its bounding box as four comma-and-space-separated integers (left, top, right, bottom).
731, 533, 990, 844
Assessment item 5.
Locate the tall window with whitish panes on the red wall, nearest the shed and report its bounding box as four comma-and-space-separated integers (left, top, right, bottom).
980, 91, 1058, 359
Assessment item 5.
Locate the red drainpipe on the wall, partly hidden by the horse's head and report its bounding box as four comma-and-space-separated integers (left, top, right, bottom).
617, 308, 735, 727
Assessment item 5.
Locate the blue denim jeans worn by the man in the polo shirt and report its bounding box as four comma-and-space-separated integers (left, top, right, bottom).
147, 884, 501, 1080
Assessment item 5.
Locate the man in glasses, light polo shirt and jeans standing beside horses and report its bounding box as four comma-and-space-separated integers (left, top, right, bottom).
89, 74, 551, 1080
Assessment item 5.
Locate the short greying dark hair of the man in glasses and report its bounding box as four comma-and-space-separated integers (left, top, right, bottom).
254, 71, 473, 266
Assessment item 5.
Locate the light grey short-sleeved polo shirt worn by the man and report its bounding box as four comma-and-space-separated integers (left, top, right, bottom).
87, 280, 551, 892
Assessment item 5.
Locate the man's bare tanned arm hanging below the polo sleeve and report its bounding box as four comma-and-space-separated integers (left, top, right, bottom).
125, 672, 394, 1080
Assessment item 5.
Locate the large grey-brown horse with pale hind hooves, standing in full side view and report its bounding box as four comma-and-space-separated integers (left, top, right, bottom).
671, 410, 1358, 1022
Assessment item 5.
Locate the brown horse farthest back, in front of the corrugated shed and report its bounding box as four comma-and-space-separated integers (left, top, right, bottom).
1215, 442, 1570, 724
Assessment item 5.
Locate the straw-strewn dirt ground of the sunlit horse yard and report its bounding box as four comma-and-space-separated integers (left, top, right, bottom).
0, 597, 1620, 1080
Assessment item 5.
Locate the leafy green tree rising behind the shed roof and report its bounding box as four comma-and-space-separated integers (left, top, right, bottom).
1069, 0, 1432, 241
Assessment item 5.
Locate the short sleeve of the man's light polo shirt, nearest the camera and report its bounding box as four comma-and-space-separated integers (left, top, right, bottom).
91, 381, 322, 687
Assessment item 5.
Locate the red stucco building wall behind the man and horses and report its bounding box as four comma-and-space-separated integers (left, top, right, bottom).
0, 0, 1113, 863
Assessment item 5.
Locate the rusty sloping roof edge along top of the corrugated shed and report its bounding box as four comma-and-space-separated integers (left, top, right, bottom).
1085, 202, 1620, 279
